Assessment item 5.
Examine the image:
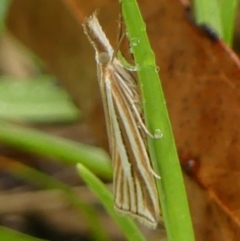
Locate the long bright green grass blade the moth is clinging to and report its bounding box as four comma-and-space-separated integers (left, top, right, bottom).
121, 0, 194, 241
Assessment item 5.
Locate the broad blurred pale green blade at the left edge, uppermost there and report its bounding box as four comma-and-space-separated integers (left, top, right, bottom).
0, 76, 80, 123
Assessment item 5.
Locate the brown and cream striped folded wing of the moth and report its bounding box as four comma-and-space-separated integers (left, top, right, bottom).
105, 72, 160, 228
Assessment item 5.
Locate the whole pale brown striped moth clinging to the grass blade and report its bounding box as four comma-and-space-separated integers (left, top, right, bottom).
83, 12, 160, 228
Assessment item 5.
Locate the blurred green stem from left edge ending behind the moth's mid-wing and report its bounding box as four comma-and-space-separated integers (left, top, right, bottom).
0, 121, 112, 179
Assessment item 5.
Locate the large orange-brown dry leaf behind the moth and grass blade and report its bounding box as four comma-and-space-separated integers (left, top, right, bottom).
5, 0, 240, 241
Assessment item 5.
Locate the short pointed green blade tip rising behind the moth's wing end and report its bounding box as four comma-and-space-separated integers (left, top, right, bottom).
77, 164, 146, 241
